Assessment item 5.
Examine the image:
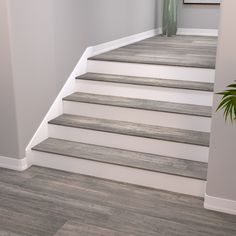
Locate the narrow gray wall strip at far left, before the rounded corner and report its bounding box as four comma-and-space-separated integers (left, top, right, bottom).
0, 1, 18, 157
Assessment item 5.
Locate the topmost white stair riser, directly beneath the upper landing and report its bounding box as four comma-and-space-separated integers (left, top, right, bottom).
87, 60, 215, 83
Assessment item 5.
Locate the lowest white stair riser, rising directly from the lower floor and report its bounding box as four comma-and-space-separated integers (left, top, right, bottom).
32, 151, 205, 197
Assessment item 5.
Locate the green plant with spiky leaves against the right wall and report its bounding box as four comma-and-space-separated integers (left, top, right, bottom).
216, 81, 236, 123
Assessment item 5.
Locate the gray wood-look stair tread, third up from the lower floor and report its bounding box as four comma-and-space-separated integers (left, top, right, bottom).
63, 92, 212, 117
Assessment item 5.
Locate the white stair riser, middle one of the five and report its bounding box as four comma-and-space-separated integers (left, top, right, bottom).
63, 101, 211, 132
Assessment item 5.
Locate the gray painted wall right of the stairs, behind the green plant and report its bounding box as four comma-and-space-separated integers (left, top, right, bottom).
207, 0, 236, 201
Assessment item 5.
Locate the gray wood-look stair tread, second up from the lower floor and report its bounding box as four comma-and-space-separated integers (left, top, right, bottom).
49, 114, 210, 146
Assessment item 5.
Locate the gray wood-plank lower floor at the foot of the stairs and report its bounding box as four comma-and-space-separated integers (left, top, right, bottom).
0, 167, 236, 236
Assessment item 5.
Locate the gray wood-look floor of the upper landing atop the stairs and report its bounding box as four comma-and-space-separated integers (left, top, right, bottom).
91, 36, 217, 69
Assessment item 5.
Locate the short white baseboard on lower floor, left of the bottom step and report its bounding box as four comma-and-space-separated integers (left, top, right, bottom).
0, 156, 31, 171
